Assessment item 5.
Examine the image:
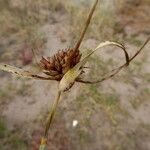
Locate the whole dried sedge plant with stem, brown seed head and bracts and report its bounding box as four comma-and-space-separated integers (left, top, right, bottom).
0, 0, 150, 150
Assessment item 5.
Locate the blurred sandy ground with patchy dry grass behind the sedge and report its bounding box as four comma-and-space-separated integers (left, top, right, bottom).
0, 0, 150, 150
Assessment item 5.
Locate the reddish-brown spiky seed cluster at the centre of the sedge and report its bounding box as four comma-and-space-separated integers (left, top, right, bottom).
40, 49, 81, 80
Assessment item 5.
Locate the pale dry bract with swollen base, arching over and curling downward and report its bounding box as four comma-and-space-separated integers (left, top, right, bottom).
59, 41, 125, 91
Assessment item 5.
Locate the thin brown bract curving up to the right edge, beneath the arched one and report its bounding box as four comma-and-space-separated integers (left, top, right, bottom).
77, 37, 150, 84
